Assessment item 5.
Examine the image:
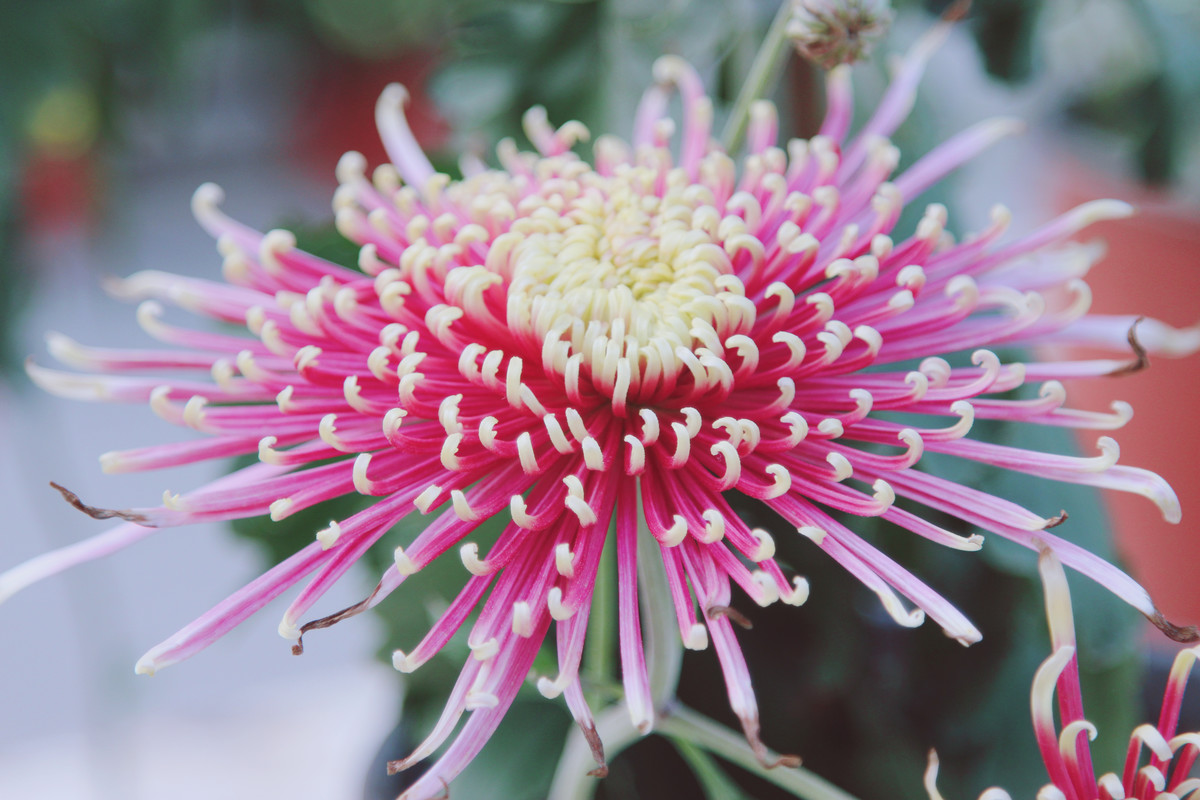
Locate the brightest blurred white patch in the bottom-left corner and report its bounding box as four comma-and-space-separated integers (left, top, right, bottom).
0, 664, 395, 800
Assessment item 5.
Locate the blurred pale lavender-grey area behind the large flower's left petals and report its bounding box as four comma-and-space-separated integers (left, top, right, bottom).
0, 23, 400, 800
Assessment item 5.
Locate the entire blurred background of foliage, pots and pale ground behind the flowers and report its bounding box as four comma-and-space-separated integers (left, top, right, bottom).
0, 0, 1200, 800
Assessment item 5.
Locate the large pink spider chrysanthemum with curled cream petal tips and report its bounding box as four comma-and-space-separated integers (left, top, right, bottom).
0, 18, 1200, 798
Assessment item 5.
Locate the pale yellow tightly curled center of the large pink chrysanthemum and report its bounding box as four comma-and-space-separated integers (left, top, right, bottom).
487, 168, 752, 407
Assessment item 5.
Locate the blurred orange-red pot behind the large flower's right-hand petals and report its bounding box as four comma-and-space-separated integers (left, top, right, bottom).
1055, 158, 1200, 625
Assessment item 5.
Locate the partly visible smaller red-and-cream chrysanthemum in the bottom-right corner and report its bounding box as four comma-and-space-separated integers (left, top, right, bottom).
925, 549, 1200, 800
